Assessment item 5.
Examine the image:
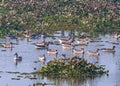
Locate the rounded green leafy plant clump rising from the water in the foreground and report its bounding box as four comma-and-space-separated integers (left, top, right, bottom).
36, 56, 108, 78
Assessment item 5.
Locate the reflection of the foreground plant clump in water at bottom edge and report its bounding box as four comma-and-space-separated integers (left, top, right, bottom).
47, 77, 96, 86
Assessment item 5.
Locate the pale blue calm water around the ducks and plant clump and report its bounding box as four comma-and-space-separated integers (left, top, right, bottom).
0, 31, 120, 86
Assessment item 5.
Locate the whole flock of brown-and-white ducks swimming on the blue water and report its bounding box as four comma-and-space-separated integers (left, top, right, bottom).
2, 33, 120, 64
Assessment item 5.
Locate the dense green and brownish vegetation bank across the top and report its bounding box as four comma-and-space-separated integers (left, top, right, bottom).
0, 0, 120, 36
